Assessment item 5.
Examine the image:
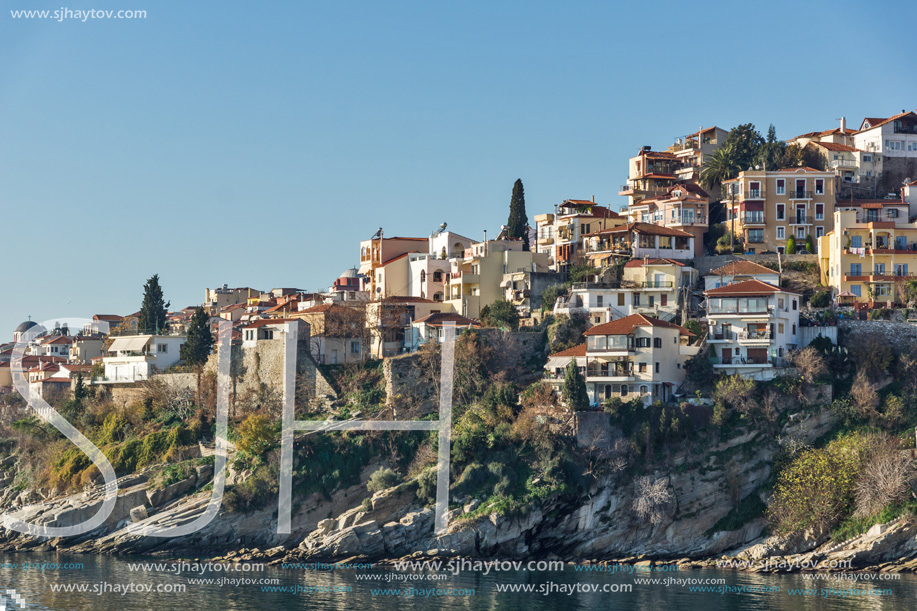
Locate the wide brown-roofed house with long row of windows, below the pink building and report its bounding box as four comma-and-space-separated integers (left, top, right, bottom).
583, 223, 694, 267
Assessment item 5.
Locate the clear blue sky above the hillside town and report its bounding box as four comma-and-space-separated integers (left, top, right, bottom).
0, 0, 917, 340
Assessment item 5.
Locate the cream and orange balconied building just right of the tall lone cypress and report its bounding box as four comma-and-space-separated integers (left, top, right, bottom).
532, 199, 626, 274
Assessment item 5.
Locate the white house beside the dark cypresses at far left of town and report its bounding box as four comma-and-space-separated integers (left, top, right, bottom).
97, 335, 186, 384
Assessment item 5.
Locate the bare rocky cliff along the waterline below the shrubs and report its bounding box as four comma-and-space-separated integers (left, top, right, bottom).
8, 411, 917, 565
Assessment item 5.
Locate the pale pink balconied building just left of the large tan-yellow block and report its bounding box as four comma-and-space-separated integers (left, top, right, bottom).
626, 182, 710, 257
